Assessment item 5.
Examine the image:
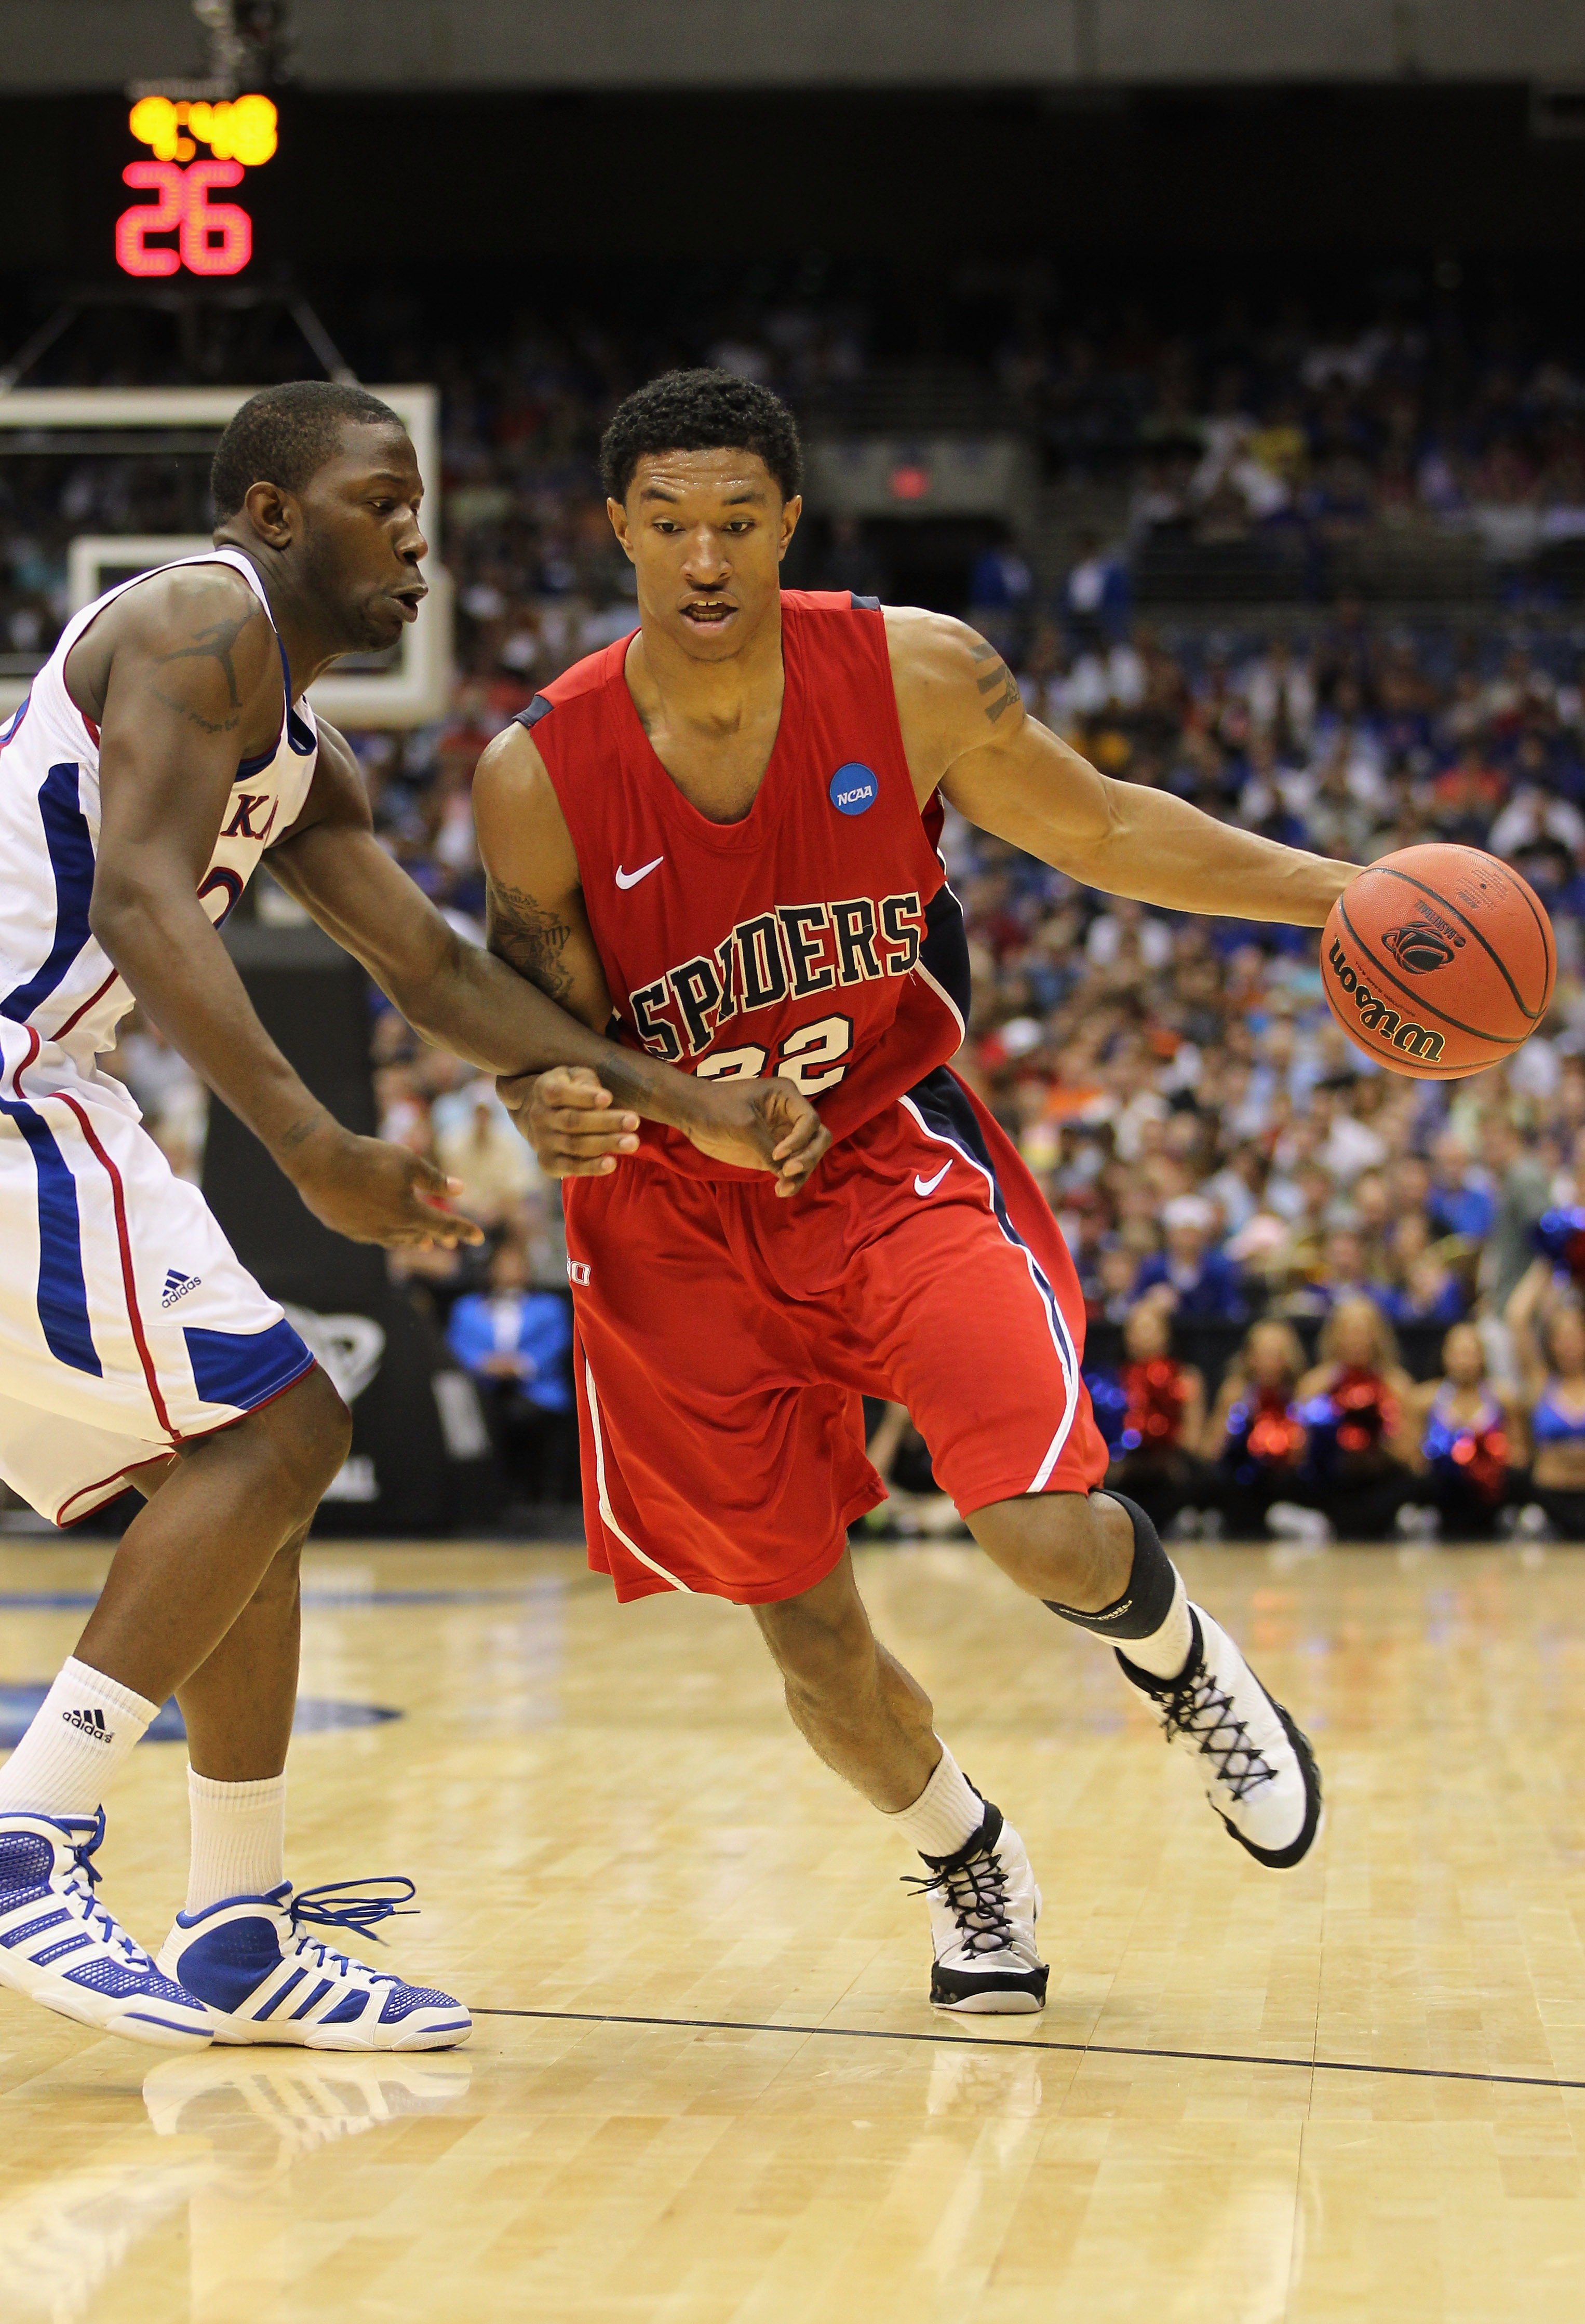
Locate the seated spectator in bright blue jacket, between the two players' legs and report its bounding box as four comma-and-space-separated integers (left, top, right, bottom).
446, 1241, 579, 1501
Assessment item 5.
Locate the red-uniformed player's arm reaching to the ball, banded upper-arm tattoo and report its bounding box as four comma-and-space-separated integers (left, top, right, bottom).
885, 611, 1360, 927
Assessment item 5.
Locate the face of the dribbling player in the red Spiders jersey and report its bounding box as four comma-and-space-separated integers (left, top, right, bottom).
607, 451, 804, 663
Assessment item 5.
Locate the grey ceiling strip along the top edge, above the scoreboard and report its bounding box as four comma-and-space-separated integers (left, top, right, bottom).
12, 0, 1585, 93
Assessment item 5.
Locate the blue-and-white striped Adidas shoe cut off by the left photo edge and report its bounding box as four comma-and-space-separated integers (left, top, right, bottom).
0, 1808, 214, 2050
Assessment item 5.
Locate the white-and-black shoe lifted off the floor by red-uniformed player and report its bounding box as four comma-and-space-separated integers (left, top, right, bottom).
1118, 1606, 1320, 1871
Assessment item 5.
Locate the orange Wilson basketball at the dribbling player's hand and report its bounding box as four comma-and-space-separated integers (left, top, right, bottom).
1320, 844, 1557, 1080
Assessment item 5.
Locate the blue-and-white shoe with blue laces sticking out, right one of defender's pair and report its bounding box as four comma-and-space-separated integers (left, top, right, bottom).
160, 1875, 474, 2050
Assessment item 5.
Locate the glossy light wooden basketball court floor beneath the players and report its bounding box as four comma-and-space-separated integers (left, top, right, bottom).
0, 1548, 1585, 2324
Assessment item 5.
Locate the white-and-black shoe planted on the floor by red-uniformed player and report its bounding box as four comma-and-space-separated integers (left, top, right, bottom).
909, 1801, 1051, 2017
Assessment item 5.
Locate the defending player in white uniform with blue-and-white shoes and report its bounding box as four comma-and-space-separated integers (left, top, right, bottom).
0, 384, 830, 2050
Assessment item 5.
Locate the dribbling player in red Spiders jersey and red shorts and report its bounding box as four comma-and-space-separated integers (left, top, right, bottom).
474, 372, 1350, 2010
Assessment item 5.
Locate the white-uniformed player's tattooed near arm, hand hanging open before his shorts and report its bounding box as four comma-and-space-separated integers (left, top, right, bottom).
79, 565, 479, 1246
